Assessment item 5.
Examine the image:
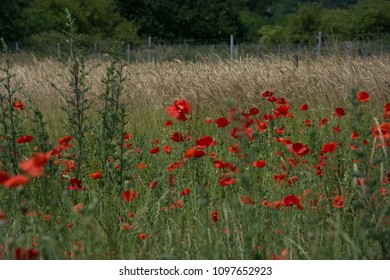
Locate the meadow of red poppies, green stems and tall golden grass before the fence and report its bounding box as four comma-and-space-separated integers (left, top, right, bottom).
0, 21, 390, 260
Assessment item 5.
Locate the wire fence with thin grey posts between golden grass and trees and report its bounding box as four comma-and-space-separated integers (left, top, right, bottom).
5, 32, 390, 63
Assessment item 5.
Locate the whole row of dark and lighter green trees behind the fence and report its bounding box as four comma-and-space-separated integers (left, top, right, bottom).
0, 0, 390, 49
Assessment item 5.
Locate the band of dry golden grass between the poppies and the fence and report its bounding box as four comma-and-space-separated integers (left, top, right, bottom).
14, 57, 390, 108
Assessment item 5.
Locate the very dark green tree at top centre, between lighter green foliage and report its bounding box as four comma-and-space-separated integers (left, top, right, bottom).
116, 0, 245, 40
